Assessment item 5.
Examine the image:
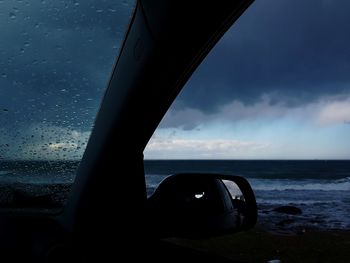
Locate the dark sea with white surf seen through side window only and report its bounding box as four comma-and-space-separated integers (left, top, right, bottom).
145, 160, 350, 233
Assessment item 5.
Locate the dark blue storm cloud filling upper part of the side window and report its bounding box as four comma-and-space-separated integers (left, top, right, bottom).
175, 0, 350, 113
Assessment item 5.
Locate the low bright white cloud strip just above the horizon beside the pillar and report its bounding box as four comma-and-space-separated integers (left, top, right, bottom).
145, 137, 270, 159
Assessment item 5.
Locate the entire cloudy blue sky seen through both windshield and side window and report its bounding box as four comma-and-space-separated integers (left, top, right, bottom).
0, 0, 350, 160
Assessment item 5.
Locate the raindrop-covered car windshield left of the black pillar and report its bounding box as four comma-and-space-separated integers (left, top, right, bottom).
0, 0, 134, 210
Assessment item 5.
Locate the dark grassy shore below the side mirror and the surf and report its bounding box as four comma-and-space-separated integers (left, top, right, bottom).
168, 225, 350, 263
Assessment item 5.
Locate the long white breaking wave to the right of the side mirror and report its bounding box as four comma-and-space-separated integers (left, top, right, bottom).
248, 177, 350, 191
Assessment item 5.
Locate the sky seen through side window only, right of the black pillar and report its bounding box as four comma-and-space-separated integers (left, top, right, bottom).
145, 0, 350, 159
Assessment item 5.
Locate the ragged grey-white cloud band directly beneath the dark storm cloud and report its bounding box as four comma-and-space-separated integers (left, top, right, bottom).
159, 94, 350, 130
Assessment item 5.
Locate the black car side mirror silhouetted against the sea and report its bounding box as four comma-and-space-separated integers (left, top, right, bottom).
148, 173, 257, 238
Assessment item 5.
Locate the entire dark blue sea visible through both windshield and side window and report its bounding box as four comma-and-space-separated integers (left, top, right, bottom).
0, 160, 350, 232
